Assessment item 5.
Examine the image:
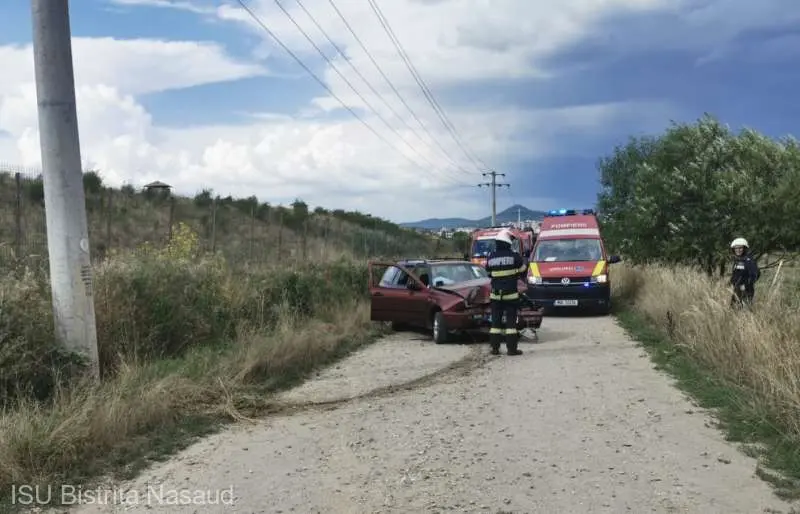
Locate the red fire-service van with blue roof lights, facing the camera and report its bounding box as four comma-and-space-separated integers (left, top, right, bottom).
527, 209, 620, 314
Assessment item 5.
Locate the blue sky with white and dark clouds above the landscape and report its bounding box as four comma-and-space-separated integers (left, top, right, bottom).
0, 0, 800, 221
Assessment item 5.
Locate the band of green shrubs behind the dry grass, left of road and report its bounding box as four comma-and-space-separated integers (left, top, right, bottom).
0, 225, 366, 405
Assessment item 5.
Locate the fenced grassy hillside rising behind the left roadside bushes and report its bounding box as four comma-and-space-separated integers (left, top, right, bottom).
0, 164, 433, 264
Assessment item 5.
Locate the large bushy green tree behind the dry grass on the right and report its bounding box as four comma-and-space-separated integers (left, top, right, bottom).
598, 115, 800, 274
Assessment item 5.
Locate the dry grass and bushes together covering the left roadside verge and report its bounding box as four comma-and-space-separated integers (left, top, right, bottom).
0, 221, 384, 500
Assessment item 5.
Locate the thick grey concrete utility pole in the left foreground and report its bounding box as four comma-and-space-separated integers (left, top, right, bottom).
31, 0, 99, 377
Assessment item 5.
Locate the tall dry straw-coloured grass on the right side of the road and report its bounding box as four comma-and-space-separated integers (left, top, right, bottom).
613, 265, 800, 437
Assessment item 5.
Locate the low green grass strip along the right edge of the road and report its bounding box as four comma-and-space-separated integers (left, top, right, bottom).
616, 306, 800, 500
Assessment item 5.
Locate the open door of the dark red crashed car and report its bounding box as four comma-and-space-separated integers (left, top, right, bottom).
369, 262, 417, 323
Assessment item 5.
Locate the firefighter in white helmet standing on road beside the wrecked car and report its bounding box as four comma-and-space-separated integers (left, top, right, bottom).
486, 230, 527, 355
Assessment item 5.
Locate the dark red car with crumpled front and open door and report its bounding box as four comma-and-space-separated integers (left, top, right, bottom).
369, 259, 544, 344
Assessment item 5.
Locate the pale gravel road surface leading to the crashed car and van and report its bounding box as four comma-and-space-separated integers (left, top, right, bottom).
70, 317, 789, 514
